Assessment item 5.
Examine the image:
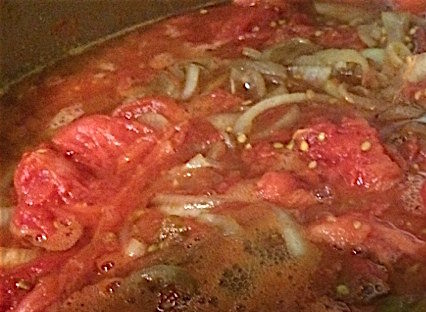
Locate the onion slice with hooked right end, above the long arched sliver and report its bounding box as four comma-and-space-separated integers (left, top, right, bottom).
294, 49, 370, 74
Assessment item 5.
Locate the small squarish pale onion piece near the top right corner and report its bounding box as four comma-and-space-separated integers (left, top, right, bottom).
382, 12, 410, 43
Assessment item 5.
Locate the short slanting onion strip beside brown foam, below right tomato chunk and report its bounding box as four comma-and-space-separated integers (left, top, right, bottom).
274, 208, 307, 258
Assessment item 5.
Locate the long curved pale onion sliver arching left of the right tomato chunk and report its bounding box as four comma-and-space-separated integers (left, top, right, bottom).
233, 93, 308, 135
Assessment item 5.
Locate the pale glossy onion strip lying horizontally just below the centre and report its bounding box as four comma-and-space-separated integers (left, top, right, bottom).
151, 194, 225, 217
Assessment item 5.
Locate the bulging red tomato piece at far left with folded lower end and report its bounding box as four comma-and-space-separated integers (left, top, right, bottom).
11, 147, 90, 250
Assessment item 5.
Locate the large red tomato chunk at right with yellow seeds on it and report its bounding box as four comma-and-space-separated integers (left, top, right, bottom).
296, 118, 401, 191
